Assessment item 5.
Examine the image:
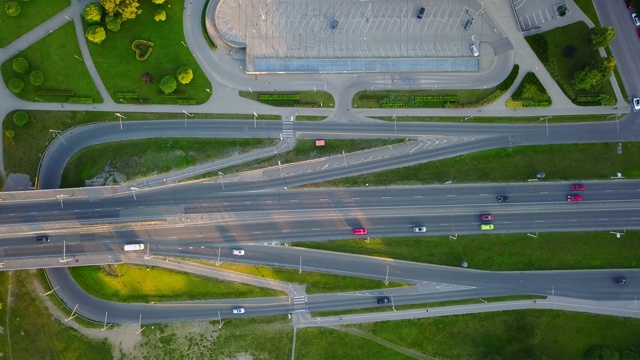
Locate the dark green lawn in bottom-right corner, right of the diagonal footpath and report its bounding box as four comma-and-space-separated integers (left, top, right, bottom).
352, 310, 640, 360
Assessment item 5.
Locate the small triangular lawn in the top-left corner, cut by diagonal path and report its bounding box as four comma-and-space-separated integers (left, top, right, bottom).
0, 0, 71, 47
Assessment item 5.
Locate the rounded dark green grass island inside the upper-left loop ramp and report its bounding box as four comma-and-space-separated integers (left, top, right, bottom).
60, 138, 277, 188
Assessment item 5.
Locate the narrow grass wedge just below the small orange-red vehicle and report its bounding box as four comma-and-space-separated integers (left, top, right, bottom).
208, 139, 404, 177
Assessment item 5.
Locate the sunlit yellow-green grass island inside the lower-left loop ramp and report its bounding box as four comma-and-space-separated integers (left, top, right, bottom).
69, 264, 286, 303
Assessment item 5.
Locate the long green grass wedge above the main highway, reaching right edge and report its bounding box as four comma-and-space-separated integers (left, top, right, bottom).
311, 142, 640, 187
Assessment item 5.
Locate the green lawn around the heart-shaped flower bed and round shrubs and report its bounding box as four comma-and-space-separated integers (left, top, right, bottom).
85, 1, 215, 104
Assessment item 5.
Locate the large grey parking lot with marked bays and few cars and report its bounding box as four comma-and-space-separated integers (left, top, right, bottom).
215, 0, 483, 70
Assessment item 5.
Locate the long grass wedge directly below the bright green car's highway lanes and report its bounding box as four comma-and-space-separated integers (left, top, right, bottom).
293, 231, 640, 271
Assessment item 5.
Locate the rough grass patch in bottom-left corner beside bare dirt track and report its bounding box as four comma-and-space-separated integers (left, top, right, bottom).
0, 271, 113, 360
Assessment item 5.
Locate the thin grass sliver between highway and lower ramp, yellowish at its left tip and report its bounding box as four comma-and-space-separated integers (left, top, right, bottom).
185, 259, 412, 295
